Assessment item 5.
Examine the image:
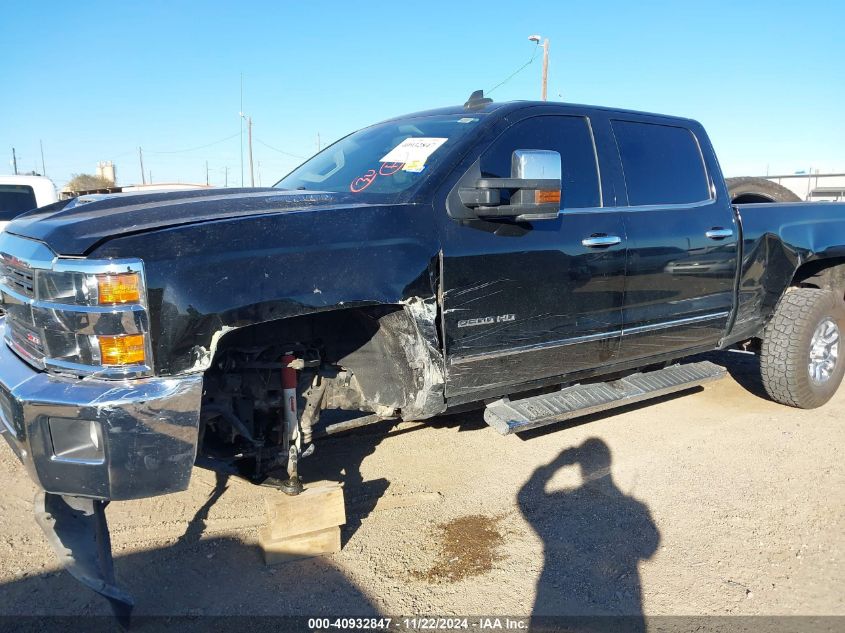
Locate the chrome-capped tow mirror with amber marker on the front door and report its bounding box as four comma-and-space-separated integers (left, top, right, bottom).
458, 149, 561, 221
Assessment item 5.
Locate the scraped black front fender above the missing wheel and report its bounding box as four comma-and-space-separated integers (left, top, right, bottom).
91, 199, 439, 375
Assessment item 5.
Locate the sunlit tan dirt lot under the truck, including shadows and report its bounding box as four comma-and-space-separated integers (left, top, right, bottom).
0, 354, 845, 616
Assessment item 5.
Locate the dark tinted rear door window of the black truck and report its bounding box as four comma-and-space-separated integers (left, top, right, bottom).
612, 120, 710, 206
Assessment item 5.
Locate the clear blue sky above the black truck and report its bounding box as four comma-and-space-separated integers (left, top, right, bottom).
0, 0, 845, 186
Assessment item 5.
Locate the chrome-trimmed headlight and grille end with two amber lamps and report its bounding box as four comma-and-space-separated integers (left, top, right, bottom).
0, 233, 153, 378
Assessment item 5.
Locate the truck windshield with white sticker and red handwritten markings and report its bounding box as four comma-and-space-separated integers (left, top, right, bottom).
275, 114, 480, 196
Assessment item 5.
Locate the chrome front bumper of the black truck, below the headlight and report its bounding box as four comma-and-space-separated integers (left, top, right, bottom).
0, 318, 202, 501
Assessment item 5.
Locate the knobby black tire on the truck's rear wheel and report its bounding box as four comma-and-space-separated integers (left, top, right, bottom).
760, 288, 845, 409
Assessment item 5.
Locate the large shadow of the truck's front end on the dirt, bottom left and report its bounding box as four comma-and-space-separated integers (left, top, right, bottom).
0, 538, 378, 633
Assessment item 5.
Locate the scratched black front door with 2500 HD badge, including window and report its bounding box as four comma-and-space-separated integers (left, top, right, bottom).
441, 115, 626, 397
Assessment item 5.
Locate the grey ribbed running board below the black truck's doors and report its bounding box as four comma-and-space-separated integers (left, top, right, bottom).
484, 361, 727, 435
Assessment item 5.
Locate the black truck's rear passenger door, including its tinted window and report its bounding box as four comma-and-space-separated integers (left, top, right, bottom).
610, 119, 738, 360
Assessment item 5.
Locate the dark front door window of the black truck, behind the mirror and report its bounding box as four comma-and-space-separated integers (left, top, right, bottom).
481, 115, 601, 209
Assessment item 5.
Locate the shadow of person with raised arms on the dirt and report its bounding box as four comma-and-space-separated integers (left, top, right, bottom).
518, 438, 660, 631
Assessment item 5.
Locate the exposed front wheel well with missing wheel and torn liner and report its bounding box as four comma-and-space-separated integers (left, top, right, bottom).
199, 300, 445, 477
